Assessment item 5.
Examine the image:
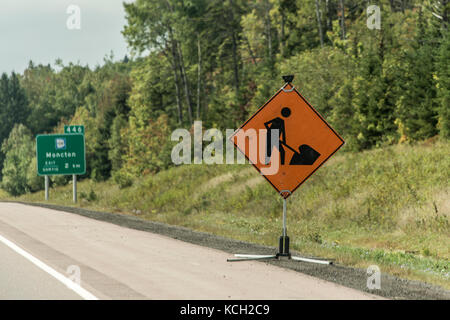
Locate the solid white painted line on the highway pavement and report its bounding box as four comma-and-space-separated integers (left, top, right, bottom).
0, 235, 98, 300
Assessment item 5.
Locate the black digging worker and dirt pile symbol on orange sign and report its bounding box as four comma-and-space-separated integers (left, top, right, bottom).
264, 107, 320, 165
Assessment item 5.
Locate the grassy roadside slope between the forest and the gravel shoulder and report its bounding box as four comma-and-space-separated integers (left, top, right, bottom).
0, 142, 450, 289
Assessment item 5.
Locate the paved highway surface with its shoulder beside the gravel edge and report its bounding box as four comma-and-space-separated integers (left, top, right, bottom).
0, 203, 379, 299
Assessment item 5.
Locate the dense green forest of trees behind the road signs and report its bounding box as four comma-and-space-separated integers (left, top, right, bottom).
0, 0, 450, 196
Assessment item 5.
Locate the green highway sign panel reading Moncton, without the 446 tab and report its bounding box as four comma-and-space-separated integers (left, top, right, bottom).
36, 133, 86, 176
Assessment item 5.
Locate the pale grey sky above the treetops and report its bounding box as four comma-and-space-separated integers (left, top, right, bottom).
0, 0, 132, 73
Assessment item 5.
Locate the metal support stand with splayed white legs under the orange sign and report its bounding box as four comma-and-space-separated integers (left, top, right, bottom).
227, 190, 333, 265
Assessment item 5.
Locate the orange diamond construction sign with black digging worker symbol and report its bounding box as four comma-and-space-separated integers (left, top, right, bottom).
230, 83, 344, 199
